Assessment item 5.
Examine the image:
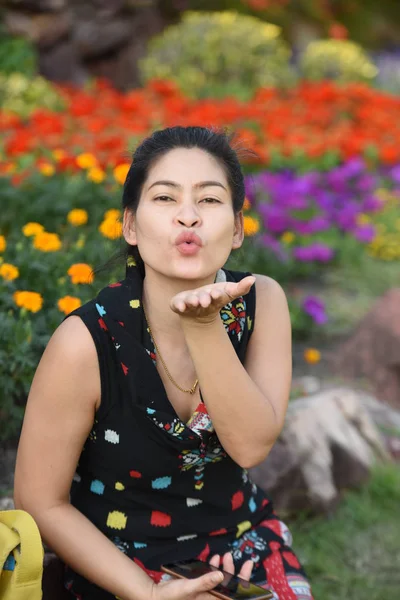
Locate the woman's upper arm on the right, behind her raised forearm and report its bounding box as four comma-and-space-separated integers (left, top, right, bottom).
245, 275, 292, 430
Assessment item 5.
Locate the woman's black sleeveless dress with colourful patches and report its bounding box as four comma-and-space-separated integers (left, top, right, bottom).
65, 258, 312, 600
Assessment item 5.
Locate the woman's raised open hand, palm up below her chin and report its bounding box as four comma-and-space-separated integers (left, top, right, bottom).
170, 275, 256, 323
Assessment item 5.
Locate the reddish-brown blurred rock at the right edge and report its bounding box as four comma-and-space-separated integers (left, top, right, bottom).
332, 288, 400, 408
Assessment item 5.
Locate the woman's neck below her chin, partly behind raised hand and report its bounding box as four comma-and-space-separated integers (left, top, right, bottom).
143, 267, 216, 339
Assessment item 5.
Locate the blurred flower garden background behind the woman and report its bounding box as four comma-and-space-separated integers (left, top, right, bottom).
0, 0, 400, 600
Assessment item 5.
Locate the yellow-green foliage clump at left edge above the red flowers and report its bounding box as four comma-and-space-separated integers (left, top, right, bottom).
0, 72, 64, 118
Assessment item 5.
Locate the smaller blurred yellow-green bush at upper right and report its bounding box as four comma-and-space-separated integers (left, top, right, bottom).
301, 40, 378, 83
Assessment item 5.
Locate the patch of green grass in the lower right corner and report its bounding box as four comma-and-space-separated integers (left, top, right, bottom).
289, 464, 400, 600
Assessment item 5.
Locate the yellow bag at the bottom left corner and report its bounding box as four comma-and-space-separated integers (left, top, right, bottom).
0, 510, 44, 600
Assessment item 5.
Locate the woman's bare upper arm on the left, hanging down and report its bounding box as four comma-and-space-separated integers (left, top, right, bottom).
14, 316, 100, 511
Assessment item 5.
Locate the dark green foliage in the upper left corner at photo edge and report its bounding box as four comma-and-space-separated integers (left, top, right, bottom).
0, 24, 37, 77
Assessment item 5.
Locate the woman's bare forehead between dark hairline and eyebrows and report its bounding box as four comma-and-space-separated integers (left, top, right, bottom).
148, 148, 227, 185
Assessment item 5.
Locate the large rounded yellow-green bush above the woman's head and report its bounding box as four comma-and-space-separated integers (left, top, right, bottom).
139, 11, 294, 98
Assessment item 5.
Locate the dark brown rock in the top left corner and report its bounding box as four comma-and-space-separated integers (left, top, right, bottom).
4, 10, 72, 49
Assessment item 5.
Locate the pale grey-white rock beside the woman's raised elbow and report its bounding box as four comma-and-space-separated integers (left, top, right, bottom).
250, 388, 392, 514
